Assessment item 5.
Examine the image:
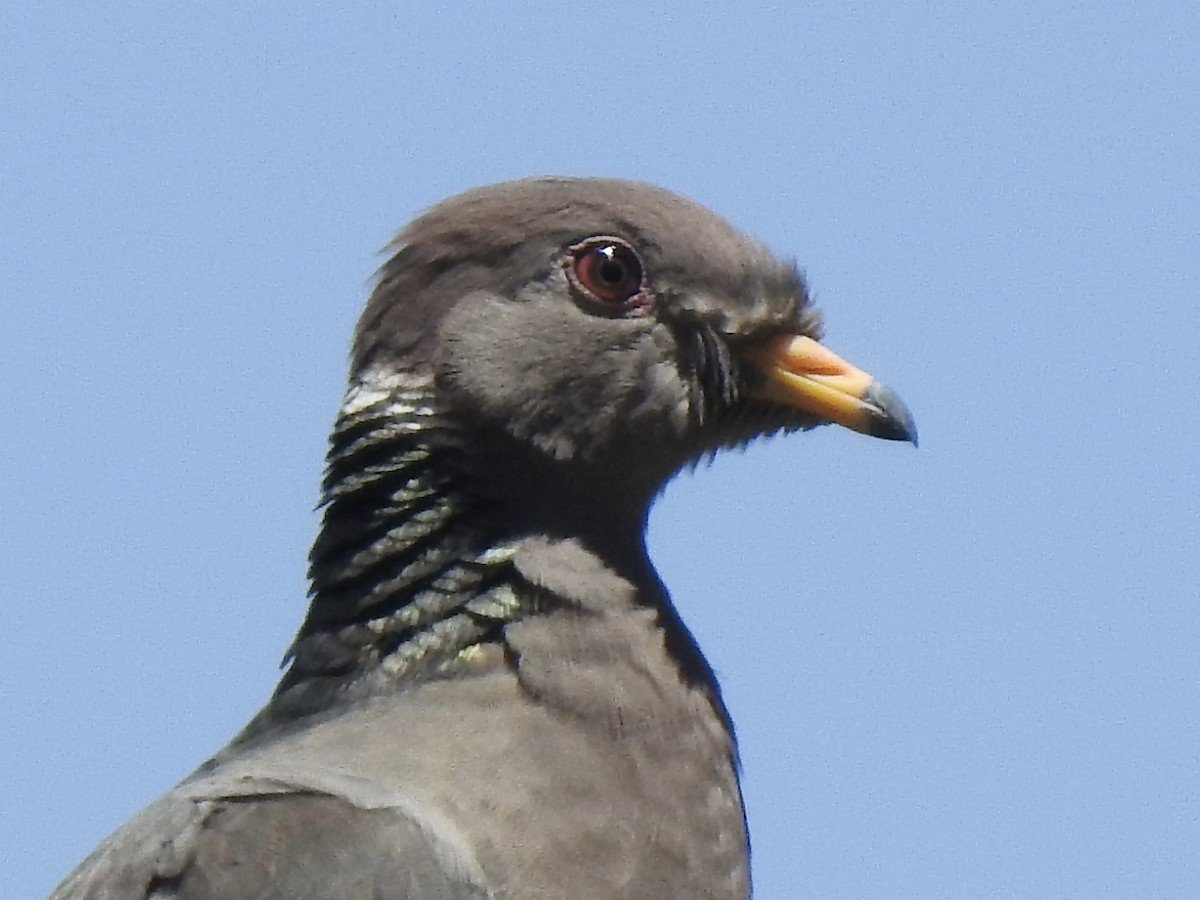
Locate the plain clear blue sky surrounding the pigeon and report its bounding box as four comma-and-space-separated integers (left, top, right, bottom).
0, 0, 1200, 900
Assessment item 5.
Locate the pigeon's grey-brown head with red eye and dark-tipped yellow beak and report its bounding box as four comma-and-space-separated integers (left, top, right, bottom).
353, 178, 916, 508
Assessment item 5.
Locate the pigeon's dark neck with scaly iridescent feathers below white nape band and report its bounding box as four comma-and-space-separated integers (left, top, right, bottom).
239, 374, 698, 743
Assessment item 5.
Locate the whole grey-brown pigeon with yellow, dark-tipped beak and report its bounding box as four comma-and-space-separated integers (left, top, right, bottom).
46, 178, 916, 900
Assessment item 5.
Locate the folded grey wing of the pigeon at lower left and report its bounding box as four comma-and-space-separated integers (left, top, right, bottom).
50, 780, 490, 900
